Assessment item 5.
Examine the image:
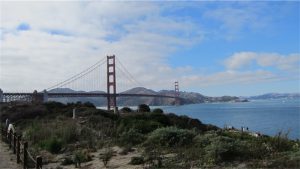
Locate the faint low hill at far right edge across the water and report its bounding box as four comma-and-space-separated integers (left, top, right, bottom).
246, 93, 300, 100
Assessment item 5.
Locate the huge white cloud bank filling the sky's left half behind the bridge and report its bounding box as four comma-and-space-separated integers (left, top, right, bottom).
0, 2, 201, 91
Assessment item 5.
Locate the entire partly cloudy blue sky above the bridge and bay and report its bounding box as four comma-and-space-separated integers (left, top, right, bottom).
0, 1, 300, 96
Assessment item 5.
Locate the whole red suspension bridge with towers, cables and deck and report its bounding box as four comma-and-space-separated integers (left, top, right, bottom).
0, 55, 180, 110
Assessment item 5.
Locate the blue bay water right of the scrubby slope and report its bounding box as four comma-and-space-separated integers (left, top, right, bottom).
156, 99, 300, 139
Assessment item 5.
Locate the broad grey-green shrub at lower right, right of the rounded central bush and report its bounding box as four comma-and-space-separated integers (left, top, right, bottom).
193, 132, 270, 164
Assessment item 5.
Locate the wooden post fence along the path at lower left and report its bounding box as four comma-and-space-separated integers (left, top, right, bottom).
1, 126, 43, 169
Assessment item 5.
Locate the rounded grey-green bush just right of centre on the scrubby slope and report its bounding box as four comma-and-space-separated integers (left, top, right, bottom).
146, 127, 196, 147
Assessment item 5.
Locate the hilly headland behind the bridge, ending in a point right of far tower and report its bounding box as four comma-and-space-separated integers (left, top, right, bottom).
49, 87, 244, 106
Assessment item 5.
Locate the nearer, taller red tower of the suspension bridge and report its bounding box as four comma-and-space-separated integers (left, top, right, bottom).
107, 55, 117, 110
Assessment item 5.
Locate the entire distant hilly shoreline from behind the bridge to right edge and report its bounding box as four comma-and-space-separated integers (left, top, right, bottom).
49, 87, 300, 107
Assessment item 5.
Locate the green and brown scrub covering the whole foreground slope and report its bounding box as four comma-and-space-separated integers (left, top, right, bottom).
0, 102, 300, 168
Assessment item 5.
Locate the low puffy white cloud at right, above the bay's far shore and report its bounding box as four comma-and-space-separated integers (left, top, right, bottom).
173, 52, 300, 88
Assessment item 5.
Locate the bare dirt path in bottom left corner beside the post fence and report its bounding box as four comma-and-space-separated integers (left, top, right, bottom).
0, 140, 21, 169
